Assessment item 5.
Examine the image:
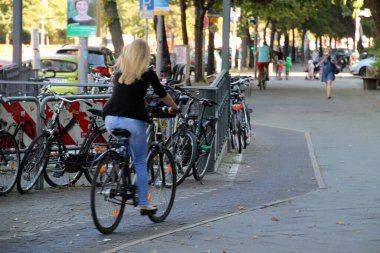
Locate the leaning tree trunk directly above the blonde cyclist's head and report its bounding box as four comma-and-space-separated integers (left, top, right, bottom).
104, 0, 124, 56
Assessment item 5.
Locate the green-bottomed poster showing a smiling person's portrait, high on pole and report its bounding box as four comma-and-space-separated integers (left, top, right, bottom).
67, 0, 98, 37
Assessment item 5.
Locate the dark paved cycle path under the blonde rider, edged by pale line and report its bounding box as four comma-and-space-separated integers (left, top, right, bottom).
0, 119, 318, 252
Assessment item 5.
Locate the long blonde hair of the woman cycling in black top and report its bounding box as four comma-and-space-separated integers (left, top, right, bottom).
115, 39, 150, 84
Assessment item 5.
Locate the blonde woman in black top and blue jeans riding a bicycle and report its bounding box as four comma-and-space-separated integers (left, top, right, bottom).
103, 39, 177, 214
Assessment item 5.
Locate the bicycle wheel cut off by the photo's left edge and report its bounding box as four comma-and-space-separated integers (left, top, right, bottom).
0, 131, 20, 195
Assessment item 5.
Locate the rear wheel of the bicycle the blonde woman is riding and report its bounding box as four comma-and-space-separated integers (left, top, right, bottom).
90, 151, 126, 234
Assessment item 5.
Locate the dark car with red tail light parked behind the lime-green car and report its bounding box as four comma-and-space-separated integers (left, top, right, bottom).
56, 45, 115, 77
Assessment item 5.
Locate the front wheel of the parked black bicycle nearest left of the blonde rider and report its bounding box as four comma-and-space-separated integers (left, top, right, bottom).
17, 133, 51, 194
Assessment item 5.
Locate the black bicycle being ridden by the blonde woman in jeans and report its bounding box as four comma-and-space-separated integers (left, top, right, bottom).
90, 106, 177, 234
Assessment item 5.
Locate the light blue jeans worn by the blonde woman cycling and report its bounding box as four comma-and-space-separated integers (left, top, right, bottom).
105, 116, 148, 206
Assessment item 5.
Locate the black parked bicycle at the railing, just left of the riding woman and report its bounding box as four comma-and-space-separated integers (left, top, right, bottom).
17, 95, 110, 194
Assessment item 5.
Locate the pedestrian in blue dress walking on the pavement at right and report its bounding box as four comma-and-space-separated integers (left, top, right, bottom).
319, 46, 337, 99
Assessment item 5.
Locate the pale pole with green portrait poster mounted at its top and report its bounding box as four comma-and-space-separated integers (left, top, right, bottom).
67, 0, 98, 83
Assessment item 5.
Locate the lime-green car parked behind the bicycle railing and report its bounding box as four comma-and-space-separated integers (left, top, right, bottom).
39, 54, 79, 94
